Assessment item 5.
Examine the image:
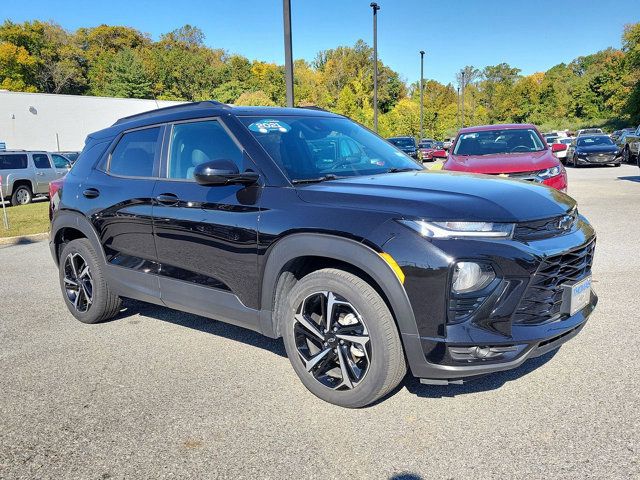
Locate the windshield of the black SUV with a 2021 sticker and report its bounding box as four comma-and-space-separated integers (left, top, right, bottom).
239, 116, 422, 181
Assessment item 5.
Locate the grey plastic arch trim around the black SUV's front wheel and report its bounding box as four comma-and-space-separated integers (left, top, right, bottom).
260, 233, 417, 338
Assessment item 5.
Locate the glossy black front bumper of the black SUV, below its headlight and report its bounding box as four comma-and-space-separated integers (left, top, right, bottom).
385, 217, 598, 384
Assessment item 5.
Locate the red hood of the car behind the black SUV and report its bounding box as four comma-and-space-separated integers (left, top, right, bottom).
443, 149, 559, 174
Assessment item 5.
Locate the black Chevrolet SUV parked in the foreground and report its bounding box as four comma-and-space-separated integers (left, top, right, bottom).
50, 102, 597, 407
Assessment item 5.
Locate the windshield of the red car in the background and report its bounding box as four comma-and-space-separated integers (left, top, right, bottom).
453, 128, 544, 155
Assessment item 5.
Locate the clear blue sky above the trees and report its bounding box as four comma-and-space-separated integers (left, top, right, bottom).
5, 0, 640, 84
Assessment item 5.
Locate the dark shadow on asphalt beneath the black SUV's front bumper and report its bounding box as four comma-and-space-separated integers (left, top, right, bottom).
400, 348, 559, 398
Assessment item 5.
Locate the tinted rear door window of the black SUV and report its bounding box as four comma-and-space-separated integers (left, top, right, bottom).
109, 127, 160, 177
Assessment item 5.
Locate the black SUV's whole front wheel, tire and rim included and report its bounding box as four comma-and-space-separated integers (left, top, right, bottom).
281, 269, 406, 408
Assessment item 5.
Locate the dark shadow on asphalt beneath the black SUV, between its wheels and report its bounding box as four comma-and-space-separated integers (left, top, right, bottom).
114, 299, 287, 357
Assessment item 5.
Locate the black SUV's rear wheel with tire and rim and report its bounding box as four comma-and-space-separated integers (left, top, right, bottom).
59, 238, 121, 323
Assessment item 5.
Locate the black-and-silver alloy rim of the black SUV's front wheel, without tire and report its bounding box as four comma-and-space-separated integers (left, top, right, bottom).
293, 291, 371, 390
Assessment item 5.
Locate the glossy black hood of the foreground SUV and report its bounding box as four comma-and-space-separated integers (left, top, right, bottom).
297, 170, 576, 222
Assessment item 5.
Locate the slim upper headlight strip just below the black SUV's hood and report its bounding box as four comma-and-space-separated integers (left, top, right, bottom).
398, 220, 514, 238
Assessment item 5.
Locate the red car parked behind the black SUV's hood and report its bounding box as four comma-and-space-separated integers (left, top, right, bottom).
442, 124, 567, 192
